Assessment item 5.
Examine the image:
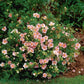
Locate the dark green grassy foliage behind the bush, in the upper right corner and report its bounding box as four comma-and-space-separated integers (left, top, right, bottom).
49, 0, 84, 28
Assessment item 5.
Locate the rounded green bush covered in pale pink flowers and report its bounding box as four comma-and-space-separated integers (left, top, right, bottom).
0, 13, 81, 79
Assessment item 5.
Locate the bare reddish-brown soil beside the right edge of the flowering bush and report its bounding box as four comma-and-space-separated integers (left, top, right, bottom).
63, 31, 84, 77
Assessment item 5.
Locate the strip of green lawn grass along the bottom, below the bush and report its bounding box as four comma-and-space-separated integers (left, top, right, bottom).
0, 76, 84, 84
